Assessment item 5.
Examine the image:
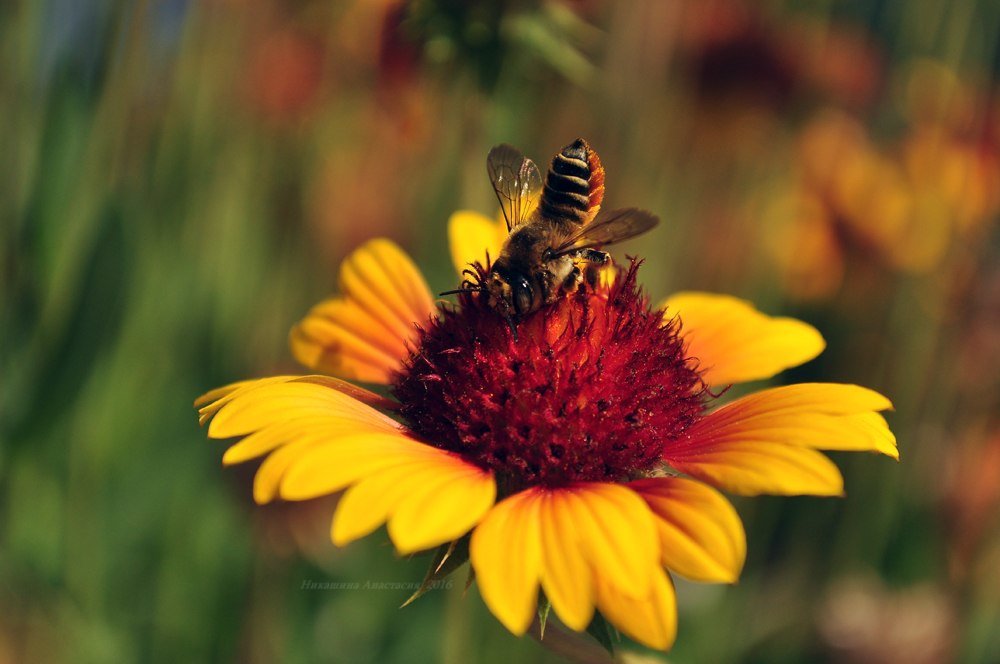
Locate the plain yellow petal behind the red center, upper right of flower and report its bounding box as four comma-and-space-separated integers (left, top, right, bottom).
663, 292, 826, 386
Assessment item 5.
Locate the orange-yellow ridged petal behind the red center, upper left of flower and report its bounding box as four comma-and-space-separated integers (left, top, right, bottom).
290, 239, 434, 384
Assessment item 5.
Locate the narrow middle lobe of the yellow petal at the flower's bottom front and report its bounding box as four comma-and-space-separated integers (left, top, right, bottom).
539, 490, 594, 632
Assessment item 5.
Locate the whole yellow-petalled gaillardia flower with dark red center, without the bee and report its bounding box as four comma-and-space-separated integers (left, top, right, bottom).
196, 213, 897, 649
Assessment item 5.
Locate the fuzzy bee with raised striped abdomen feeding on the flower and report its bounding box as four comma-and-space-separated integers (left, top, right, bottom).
448, 138, 659, 320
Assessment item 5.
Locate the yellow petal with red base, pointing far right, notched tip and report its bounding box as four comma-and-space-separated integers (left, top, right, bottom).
663, 383, 898, 495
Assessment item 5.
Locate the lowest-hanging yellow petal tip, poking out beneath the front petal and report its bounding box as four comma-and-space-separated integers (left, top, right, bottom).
597, 567, 677, 650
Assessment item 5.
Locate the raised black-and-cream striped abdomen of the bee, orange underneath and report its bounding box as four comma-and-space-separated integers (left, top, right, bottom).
539, 139, 604, 224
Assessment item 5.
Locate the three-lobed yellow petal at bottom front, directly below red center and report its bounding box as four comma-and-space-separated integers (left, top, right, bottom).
470, 482, 660, 634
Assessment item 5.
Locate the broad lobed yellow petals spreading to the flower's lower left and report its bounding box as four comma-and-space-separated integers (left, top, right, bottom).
199, 376, 496, 553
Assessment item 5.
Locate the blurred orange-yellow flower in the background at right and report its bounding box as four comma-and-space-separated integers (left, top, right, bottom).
762, 101, 1000, 299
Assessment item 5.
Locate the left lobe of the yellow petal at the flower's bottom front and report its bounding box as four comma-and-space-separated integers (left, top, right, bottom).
469, 489, 541, 636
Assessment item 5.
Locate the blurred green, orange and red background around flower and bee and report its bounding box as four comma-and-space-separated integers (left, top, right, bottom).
0, 0, 1000, 664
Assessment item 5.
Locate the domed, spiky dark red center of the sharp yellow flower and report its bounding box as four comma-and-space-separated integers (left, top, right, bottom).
393, 262, 708, 489
